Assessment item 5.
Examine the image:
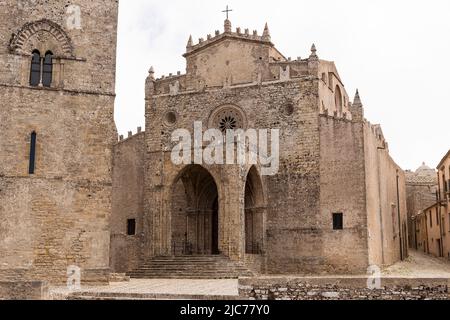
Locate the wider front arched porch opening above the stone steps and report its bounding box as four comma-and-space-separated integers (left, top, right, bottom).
171, 165, 219, 256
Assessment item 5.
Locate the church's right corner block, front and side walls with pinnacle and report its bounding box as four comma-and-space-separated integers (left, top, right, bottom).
320, 104, 408, 273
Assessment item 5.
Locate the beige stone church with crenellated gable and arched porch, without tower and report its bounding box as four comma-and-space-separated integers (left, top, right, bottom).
111, 19, 408, 274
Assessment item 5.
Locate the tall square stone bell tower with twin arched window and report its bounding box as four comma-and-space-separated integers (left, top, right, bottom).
0, 0, 118, 283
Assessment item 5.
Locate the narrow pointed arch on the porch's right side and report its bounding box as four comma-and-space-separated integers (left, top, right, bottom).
245, 167, 265, 255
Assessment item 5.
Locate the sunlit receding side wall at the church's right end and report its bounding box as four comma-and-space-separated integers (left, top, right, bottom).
364, 122, 408, 266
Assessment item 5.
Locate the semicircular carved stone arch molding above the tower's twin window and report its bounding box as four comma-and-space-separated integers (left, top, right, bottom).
9, 19, 74, 58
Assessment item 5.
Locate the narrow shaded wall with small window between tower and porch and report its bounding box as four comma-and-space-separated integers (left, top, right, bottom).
110, 132, 145, 272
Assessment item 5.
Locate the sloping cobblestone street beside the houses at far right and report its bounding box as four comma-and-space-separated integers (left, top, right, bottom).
382, 250, 450, 278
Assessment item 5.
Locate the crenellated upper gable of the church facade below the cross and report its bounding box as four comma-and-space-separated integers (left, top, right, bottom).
146, 38, 321, 99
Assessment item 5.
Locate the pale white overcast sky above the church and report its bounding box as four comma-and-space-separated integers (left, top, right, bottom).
115, 0, 450, 169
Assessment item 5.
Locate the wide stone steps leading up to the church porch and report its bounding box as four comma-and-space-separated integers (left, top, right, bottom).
127, 255, 254, 279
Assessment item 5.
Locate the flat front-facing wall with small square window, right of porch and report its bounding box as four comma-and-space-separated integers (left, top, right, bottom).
319, 116, 368, 273
